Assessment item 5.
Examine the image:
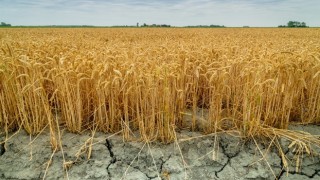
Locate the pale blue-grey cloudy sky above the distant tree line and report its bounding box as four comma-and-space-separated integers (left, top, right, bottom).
0, 0, 320, 27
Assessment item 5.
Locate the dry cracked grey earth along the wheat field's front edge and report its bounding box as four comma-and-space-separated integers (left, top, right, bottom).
0, 126, 320, 180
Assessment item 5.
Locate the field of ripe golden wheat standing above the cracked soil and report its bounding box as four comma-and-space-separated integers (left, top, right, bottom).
0, 28, 320, 144
